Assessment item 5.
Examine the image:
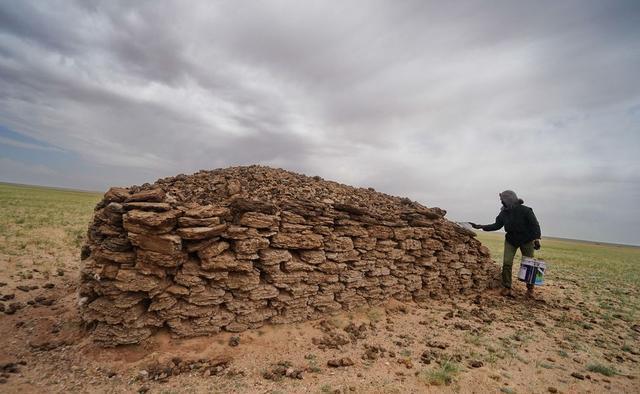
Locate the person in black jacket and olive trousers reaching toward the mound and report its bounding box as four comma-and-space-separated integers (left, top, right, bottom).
470, 190, 541, 297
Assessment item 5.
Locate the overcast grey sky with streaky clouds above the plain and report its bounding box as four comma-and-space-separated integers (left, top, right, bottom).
0, 0, 640, 244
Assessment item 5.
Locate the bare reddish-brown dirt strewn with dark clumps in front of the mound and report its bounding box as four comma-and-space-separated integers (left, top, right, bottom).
0, 258, 640, 393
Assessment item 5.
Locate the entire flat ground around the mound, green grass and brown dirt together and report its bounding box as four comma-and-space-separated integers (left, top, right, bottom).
0, 184, 640, 393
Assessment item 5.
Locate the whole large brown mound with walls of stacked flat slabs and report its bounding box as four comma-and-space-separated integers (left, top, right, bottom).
80, 166, 495, 346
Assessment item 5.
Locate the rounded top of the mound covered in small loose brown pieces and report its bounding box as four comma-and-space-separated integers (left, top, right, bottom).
109, 165, 446, 225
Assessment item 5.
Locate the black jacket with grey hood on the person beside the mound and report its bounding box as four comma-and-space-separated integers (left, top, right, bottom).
482, 190, 541, 247
